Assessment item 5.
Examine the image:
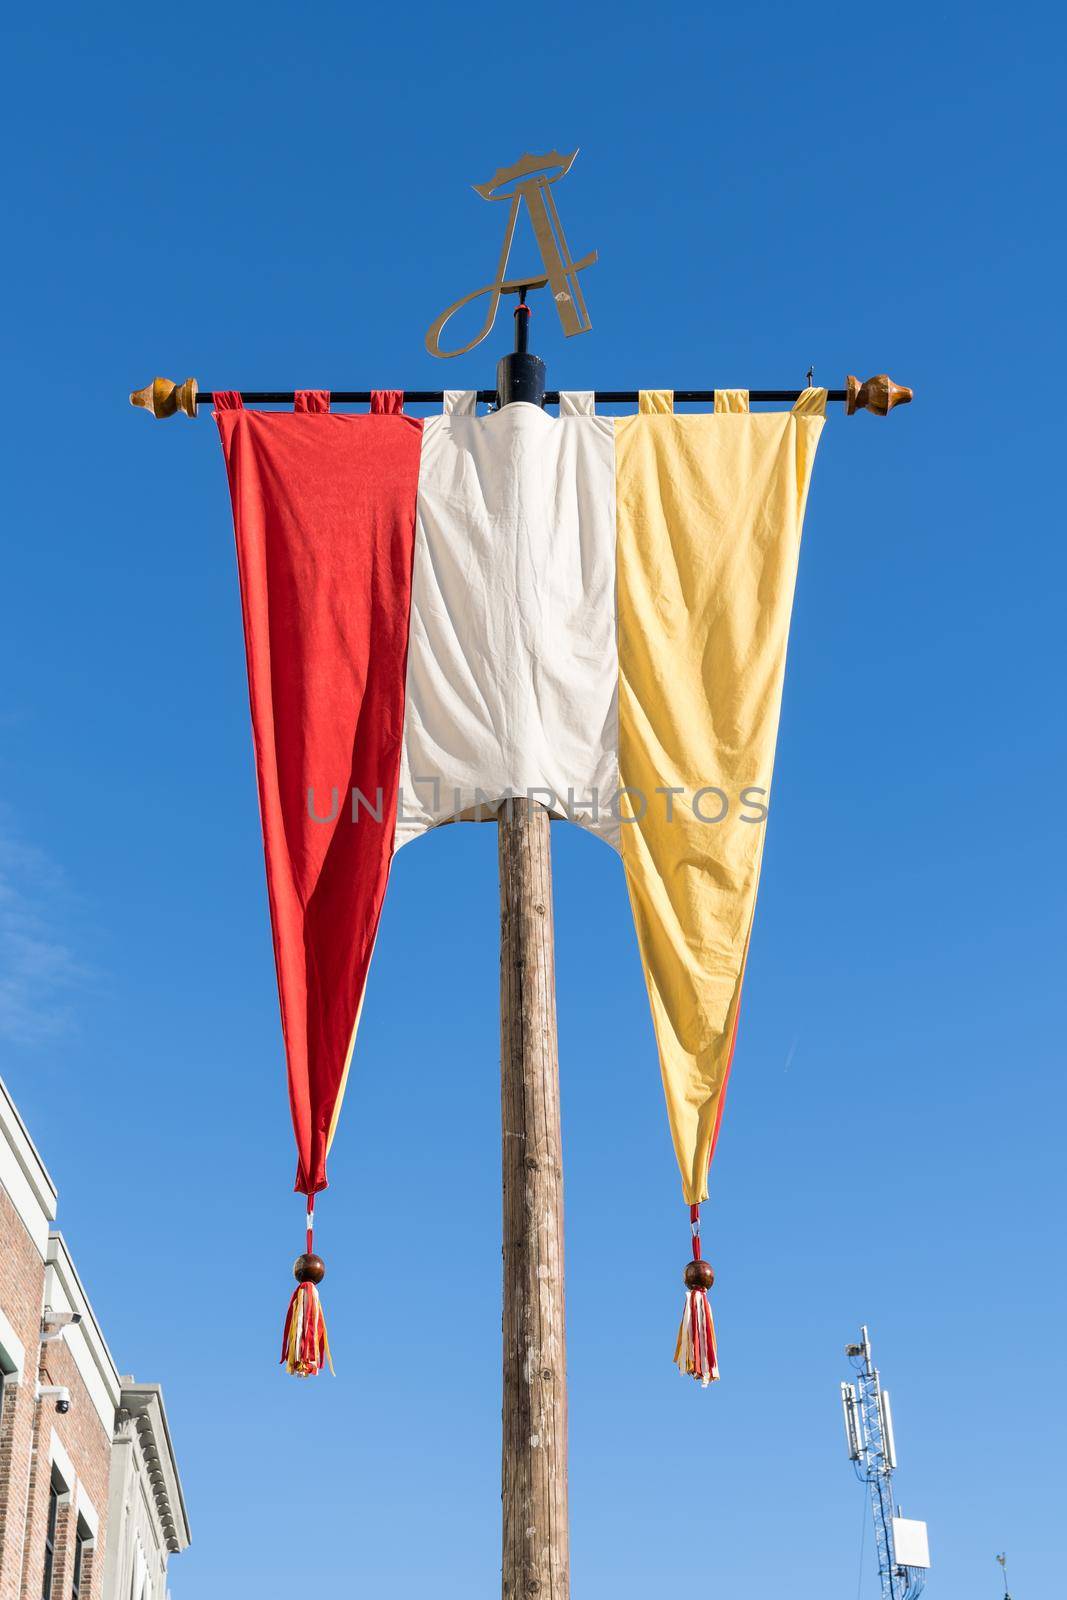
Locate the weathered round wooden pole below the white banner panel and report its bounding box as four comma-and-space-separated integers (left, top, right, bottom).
498, 797, 569, 1600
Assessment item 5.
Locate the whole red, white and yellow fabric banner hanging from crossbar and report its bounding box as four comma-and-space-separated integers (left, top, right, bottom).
214, 389, 825, 1312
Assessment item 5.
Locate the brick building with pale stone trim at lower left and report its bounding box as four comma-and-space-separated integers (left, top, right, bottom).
0, 1080, 189, 1600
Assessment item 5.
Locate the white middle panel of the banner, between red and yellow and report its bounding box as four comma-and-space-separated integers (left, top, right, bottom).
395, 405, 621, 850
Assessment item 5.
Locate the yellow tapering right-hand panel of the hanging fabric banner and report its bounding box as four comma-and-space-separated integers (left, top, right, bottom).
616, 411, 822, 1205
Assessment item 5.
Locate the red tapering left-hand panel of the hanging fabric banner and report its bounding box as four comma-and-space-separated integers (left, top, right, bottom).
218, 408, 422, 1195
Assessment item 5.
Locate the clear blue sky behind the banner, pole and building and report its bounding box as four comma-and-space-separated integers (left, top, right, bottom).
0, 3, 1065, 1600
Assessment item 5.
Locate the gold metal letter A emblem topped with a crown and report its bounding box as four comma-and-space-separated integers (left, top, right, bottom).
426, 150, 597, 355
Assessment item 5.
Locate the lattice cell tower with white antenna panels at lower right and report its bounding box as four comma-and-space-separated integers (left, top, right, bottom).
841, 1328, 929, 1600
